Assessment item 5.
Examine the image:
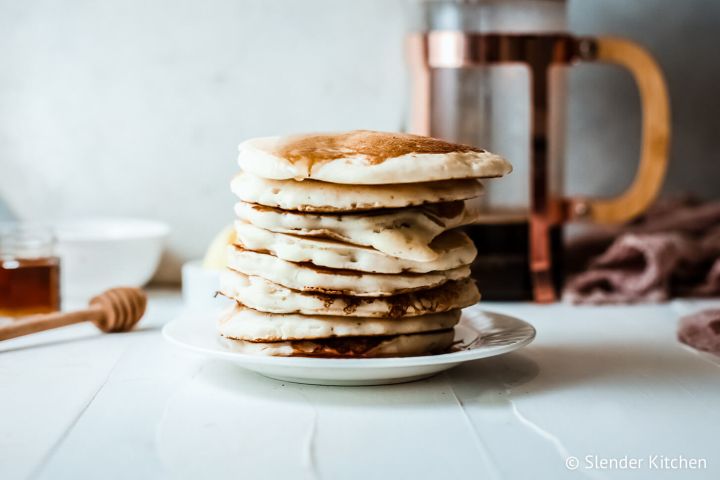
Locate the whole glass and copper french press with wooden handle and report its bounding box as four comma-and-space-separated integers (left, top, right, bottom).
407, 0, 670, 302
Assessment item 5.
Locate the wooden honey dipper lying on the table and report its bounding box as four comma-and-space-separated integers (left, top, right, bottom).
0, 287, 147, 341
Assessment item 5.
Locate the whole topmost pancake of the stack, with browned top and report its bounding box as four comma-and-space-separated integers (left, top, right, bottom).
238, 130, 512, 185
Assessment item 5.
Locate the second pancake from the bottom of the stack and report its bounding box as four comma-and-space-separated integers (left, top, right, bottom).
218, 305, 460, 342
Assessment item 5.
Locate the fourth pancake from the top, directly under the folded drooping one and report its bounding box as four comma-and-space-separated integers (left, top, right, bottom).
232, 221, 477, 273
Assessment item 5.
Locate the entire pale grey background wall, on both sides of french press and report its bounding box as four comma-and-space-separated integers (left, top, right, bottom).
0, 0, 720, 280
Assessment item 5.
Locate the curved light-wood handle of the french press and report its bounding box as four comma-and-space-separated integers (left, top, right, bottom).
568, 37, 670, 223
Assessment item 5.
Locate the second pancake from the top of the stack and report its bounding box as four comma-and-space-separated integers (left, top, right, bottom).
230, 172, 483, 212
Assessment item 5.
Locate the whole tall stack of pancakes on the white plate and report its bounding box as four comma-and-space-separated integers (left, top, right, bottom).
218, 131, 511, 357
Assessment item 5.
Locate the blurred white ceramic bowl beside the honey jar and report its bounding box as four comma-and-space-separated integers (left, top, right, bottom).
55, 218, 170, 305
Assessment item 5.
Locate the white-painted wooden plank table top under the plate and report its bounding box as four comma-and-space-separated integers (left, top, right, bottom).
0, 291, 720, 480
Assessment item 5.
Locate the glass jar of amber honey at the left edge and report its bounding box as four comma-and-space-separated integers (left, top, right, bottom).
0, 224, 60, 317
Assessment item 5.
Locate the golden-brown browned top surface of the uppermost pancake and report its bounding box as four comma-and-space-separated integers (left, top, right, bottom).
274, 130, 484, 165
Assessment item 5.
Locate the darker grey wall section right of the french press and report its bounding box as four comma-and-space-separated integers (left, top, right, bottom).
568, 0, 720, 198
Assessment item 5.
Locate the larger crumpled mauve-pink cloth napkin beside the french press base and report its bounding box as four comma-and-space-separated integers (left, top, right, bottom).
564, 199, 720, 304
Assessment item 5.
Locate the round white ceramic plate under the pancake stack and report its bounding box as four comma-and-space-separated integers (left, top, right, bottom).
163, 306, 535, 385
